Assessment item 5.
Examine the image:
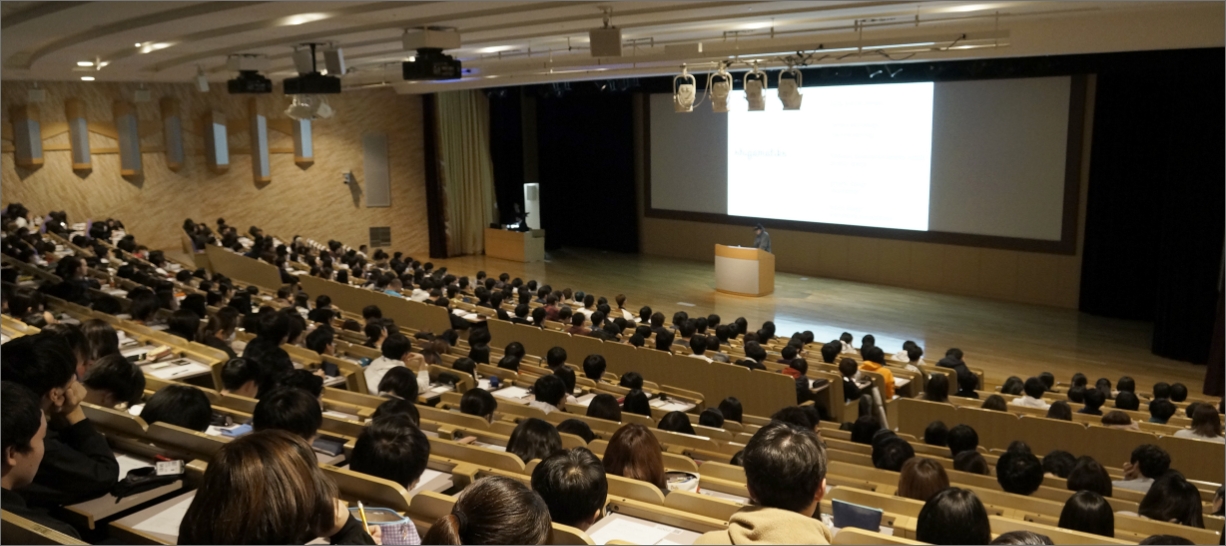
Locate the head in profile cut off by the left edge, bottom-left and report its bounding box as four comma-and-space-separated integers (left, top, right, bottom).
0, 382, 47, 490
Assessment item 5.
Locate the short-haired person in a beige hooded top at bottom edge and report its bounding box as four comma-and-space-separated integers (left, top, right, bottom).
696, 422, 834, 545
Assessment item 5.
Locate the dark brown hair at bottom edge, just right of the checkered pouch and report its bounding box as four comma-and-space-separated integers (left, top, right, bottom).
422, 476, 553, 545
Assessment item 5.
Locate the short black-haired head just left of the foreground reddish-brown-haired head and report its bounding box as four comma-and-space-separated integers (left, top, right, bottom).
532, 448, 608, 530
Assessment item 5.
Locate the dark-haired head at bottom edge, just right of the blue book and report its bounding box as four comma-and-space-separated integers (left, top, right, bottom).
916, 487, 992, 545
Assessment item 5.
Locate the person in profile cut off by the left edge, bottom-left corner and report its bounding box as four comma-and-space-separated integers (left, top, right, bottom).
0, 382, 80, 539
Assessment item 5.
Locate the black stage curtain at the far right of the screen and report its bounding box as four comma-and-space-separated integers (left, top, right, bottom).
1080, 49, 1226, 363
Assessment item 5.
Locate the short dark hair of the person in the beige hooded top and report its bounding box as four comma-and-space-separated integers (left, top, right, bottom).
742, 422, 826, 515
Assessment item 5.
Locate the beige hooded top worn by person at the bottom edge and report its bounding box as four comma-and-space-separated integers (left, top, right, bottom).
694, 507, 834, 544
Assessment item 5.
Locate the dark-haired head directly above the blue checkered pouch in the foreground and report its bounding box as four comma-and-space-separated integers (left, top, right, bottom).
349, 415, 430, 490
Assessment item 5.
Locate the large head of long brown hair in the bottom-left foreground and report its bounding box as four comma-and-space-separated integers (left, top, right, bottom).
179, 431, 337, 545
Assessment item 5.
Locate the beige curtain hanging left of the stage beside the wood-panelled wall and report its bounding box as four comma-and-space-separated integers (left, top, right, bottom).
438, 91, 494, 256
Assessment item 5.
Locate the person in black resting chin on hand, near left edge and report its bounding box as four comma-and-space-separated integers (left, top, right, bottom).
0, 333, 119, 507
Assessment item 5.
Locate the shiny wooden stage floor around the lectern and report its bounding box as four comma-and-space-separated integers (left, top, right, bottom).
430, 249, 1205, 393
